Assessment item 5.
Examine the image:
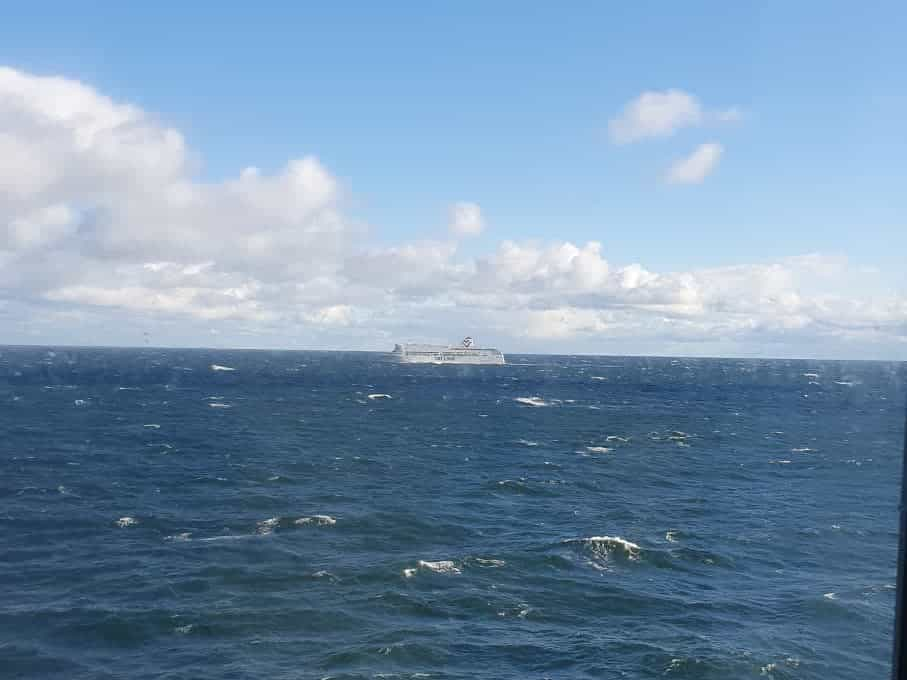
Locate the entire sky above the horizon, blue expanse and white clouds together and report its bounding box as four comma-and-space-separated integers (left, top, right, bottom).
0, 1, 907, 360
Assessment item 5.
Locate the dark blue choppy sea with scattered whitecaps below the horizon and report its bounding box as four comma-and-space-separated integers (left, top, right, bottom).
0, 347, 905, 680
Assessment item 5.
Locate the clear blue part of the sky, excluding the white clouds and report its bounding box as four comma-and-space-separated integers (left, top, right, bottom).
0, 2, 907, 356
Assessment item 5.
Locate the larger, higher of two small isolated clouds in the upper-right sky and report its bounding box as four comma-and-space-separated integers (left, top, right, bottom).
608, 89, 741, 144
